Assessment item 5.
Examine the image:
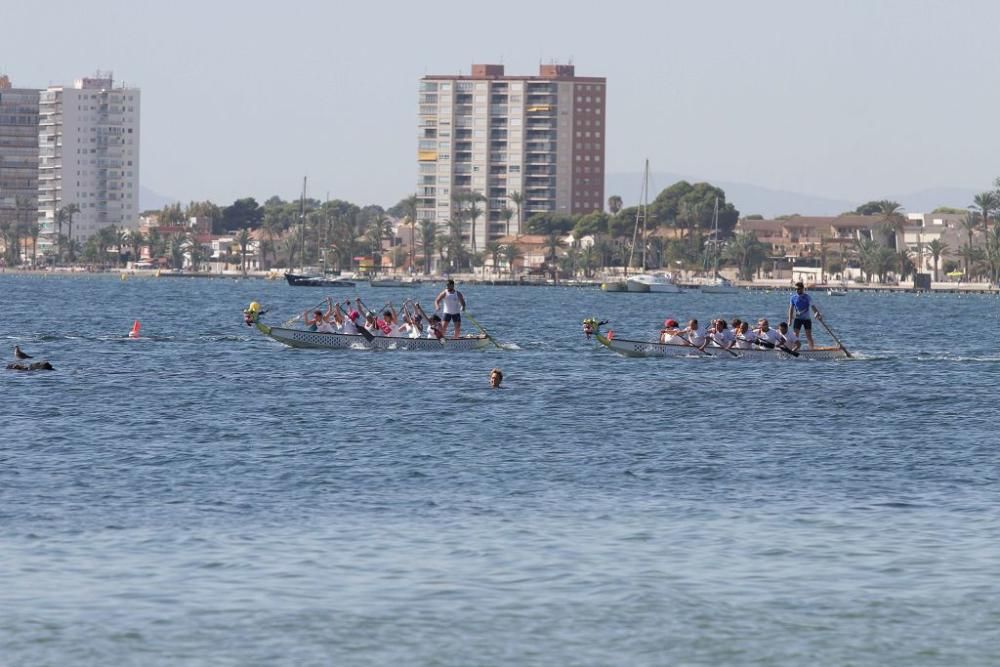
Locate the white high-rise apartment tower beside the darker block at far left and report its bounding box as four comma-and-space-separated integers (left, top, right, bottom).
38, 73, 139, 252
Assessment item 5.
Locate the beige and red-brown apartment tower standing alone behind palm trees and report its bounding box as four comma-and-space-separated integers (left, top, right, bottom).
417, 65, 607, 251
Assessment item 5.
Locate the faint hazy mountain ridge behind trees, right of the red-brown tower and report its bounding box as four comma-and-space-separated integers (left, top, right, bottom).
605, 172, 977, 218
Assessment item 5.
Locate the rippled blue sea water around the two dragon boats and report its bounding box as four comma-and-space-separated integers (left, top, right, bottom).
0, 274, 1000, 666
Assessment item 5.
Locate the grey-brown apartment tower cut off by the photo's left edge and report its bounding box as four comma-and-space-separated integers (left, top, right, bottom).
0, 75, 39, 236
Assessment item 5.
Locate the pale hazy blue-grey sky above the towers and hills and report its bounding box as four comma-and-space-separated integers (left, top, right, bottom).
7, 0, 1000, 205
